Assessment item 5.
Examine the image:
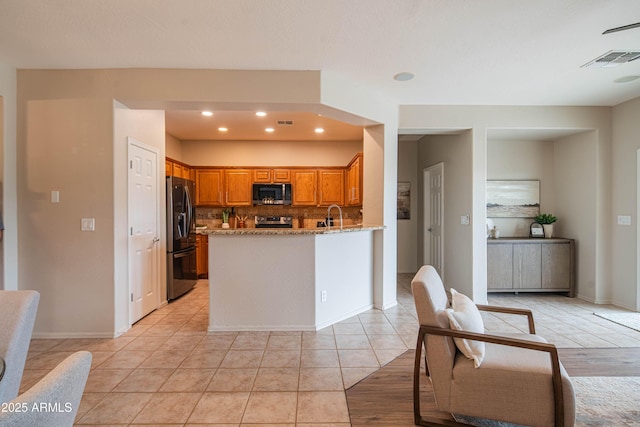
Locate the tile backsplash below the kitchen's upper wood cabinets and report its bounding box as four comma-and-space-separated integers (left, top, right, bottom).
196, 206, 362, 228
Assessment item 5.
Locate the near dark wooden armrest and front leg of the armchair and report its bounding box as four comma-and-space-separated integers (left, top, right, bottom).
416, 325, 564, 427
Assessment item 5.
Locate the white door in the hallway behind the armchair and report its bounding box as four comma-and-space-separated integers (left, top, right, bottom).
423, 163, 444, 279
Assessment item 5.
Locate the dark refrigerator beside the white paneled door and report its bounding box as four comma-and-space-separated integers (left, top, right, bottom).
167, 176, 198, 300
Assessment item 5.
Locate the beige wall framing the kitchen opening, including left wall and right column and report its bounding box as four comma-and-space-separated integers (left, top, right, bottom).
16, 69, 397, 336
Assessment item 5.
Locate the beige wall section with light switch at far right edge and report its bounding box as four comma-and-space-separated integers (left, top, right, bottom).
611, 98, 640, 311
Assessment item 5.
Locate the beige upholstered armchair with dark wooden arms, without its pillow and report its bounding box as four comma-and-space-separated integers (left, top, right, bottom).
411, 266, 575, 427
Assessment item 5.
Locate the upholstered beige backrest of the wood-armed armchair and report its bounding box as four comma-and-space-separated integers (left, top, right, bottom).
411, 265, 456, 410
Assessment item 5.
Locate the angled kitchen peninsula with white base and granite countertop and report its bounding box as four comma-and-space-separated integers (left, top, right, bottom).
202, 226, 383, 331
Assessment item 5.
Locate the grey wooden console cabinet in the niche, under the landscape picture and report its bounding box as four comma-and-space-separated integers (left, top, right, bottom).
487, 238, 575, 297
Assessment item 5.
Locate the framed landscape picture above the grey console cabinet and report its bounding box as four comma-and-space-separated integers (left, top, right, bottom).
487, 180, 540, 218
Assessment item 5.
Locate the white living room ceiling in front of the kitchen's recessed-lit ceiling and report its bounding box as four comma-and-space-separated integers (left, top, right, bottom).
0, 0, 640, 140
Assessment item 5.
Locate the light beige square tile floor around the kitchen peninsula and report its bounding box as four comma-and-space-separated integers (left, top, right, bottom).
22, 274, 640, 427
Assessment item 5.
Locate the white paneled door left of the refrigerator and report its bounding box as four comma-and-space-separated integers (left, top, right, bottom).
128, 138, 160, 323
